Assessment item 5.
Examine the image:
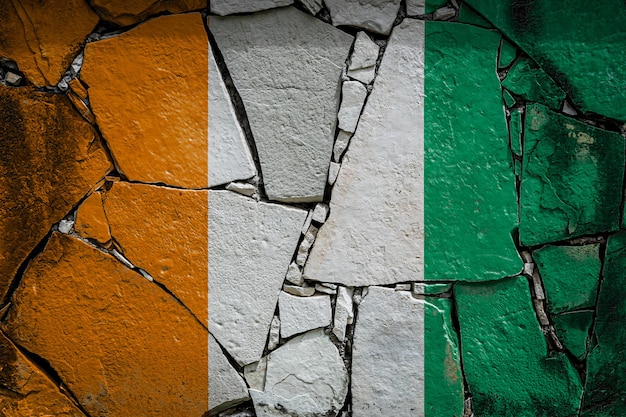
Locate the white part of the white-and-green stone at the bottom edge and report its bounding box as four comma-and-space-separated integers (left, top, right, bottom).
351, 287, 425, 417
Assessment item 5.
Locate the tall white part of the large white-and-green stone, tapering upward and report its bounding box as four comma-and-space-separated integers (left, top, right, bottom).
303, 19, 424, 286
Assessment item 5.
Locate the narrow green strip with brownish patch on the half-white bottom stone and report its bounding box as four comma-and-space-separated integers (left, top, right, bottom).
424, 297, 465, 417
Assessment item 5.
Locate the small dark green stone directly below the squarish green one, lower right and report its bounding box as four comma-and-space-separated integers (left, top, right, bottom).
552, 311, 593, 360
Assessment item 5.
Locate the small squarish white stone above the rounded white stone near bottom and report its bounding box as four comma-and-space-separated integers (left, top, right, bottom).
278, 292, 332, 339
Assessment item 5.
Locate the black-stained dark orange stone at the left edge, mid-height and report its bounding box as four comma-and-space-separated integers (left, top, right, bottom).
0, 86, 110, 298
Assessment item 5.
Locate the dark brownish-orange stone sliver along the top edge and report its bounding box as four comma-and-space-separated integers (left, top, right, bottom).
89, 0, 204, 26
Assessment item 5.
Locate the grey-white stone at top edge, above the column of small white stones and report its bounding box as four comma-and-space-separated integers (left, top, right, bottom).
325, 0, 401, 35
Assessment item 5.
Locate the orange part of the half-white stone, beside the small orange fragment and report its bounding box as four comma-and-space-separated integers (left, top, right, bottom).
104, 182, 208, 324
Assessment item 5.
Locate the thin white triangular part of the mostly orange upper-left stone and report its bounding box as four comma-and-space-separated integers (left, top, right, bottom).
209, 47, 256, 187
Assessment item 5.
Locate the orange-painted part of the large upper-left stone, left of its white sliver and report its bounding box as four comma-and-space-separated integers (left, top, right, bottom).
81, 13, 209, 188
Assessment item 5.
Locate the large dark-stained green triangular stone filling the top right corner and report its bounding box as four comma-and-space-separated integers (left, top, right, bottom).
460, 0, 626, 120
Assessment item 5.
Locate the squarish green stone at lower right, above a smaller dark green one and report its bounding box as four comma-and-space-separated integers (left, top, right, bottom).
533, 245, 602, 313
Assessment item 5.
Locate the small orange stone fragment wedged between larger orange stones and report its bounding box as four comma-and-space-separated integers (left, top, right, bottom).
74, 192, 111, 246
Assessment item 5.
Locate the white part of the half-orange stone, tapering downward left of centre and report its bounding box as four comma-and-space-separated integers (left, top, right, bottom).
209, 191, 307, 365
